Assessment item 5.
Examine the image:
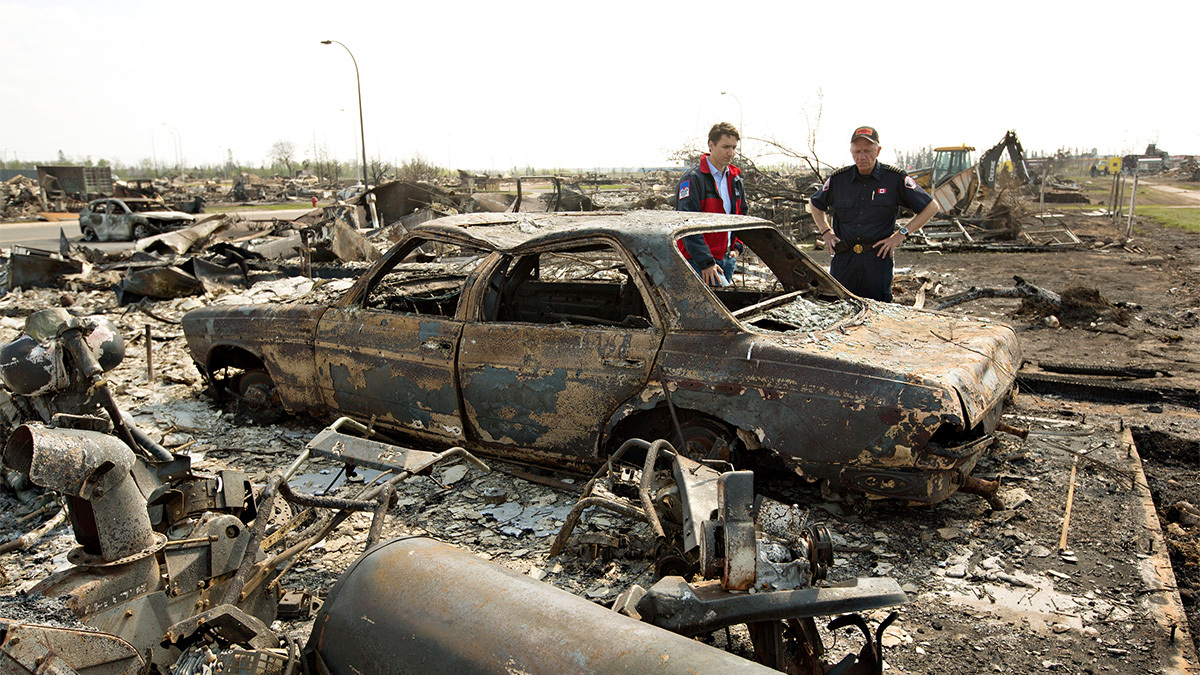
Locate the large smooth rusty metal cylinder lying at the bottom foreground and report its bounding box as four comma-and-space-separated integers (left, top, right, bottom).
306, 537, 778, 675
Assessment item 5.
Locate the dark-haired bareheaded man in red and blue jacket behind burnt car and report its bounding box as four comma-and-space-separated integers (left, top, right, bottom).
676, 121, 746, 286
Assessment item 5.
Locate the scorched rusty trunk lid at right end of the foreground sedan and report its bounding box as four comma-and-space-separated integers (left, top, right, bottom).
748, 300, 1021, 428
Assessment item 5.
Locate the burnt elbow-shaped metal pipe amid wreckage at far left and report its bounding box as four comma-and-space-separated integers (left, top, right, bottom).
4, 424, 156, 562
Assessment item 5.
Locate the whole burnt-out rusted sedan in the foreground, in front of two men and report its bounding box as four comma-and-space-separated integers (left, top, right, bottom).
184, 211, 1020, 502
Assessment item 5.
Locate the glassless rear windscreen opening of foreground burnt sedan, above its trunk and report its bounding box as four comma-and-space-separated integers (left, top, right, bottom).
680, 228, 860, 333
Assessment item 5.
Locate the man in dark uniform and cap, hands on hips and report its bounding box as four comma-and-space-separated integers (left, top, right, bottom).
809, 126, 938, 303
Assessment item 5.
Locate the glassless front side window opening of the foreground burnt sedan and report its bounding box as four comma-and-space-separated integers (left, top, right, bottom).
364, 241, 490, 317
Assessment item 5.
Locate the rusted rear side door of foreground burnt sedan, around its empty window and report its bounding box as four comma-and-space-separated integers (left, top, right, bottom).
457, 234, 666, 466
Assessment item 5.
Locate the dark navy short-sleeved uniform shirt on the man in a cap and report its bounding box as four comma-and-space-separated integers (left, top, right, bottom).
809, 161, 932, 241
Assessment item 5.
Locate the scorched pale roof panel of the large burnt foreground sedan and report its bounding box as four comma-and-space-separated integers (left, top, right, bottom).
410, 211, 772, 251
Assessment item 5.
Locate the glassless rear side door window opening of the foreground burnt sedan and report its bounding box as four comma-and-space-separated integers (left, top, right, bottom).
485, 244, 653, 329
